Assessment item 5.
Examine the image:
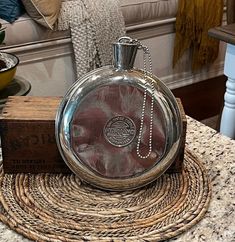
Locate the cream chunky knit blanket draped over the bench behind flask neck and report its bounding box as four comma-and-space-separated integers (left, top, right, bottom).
58, 0, 125, 79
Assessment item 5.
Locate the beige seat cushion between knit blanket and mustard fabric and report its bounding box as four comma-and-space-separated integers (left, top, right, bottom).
120, 0, 178, 26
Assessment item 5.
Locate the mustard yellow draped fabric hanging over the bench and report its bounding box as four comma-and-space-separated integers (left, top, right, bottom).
173, 0, 224, 70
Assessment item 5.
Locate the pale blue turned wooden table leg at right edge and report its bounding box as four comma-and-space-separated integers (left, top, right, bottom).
220, 44, 235, 139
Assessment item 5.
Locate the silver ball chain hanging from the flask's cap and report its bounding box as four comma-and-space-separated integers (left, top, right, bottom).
136, 41, 155, 159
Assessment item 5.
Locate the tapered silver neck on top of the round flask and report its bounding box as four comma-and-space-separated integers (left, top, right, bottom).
113, 38, 138, 70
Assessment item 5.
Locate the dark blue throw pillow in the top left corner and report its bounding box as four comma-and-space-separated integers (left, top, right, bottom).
0, 0, 25, 23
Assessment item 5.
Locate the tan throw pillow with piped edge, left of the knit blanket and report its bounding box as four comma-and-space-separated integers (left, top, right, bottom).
22, 0, 62, 29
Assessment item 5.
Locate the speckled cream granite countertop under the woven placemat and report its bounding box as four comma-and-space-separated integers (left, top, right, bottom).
0, 117, 235, 242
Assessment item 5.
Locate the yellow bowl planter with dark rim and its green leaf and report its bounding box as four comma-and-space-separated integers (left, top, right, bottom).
0, 24, 19, 90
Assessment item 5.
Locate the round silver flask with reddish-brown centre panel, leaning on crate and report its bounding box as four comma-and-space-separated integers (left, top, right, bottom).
55, 38, 182, 190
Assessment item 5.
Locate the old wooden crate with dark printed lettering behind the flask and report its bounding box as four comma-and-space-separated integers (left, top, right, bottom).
0, 96, 186, 173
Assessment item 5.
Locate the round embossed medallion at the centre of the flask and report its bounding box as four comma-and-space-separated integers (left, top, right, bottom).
104, 116, 136, 147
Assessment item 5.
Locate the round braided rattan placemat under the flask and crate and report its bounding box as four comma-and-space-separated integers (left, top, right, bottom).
0, 150, 211, 241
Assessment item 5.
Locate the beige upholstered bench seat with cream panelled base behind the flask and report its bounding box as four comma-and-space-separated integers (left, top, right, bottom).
0, 0, 228, 96
